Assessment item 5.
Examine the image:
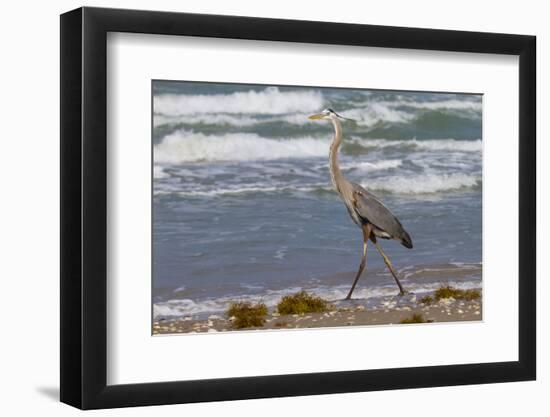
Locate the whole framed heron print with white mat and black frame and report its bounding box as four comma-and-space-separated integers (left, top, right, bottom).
61, 8, 536, 409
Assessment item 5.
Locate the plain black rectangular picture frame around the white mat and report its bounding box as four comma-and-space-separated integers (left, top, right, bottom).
60, 7, 536, 409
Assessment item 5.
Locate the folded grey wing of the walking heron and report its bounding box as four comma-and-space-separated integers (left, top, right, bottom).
352, 184, 412, 248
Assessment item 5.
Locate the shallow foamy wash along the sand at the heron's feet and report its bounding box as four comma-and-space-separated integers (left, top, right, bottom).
153, 263, 483, 321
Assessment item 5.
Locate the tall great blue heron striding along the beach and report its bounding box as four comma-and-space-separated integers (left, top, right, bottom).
309, 105, 412, 300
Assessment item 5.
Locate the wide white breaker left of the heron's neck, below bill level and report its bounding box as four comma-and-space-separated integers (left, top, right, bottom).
154, 130, 329, 164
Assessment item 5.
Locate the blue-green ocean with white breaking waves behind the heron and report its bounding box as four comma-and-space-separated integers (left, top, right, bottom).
152, 81, 482, 318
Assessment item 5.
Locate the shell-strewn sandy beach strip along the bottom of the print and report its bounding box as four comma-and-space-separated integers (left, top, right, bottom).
153, 294, 482, 335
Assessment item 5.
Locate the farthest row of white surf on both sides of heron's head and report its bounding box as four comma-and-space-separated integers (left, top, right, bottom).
153, 95, 481, 127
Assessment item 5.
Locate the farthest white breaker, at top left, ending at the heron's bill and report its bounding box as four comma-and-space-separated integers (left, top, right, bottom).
153, 87, 323, 116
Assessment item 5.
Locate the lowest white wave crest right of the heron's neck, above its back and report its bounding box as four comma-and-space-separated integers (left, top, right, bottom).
362, 173, 481, 194
